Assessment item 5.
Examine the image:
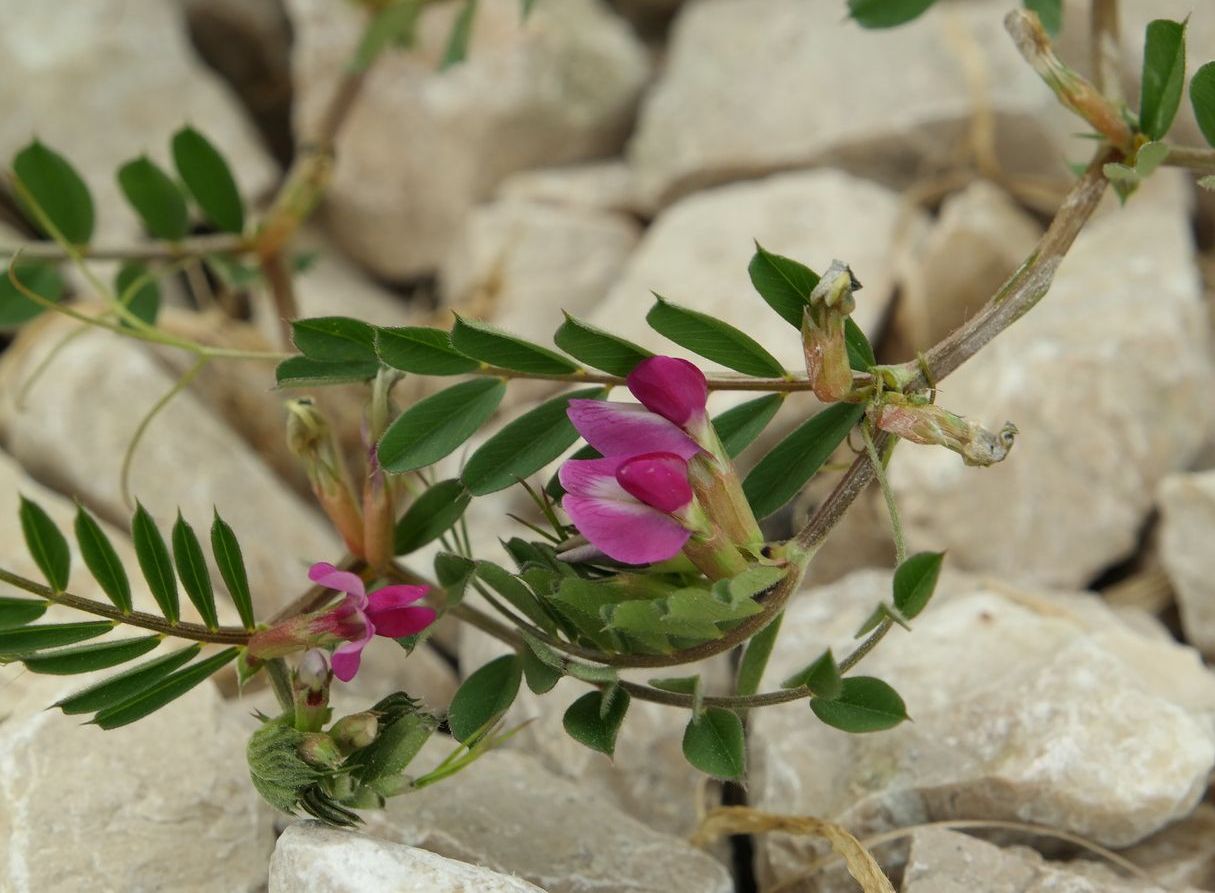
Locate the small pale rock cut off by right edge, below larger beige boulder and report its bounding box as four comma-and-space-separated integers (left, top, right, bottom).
1160, 471, 1215, 654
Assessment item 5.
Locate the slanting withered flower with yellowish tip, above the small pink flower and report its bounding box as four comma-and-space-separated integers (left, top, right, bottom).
287, 399, 363, 556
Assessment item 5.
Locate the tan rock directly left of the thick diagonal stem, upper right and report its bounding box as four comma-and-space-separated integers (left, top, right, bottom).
895, 180, 1042, 350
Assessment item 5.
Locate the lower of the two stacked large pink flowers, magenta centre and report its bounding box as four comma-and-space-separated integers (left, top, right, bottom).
559, 452, 693, 564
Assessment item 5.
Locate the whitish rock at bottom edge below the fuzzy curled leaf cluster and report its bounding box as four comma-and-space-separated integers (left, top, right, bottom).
269, 821, 544, 893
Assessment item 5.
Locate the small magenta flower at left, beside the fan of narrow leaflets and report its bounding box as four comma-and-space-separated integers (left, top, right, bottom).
307, 561, 436, 682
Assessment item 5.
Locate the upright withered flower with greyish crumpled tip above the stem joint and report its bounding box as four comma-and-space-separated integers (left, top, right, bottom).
802, 260, 860, 403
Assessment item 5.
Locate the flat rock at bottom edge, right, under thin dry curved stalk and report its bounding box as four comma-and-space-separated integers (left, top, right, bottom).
903, 829, 1174, 893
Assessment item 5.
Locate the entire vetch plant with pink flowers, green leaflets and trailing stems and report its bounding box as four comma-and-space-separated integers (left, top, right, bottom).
0, 0, 1215, 884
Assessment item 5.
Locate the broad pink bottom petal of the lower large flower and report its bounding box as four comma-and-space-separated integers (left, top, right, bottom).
561, 493, 691, 564
